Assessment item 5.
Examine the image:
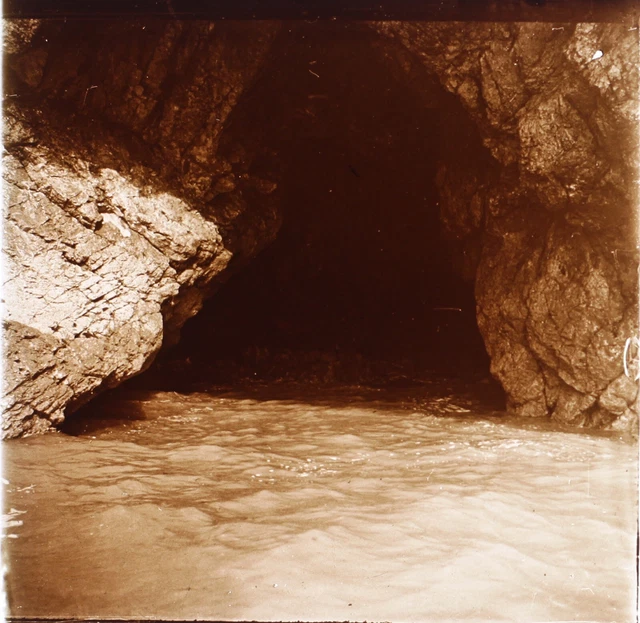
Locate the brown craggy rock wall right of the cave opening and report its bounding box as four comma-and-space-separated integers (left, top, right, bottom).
373, 23, 639, 428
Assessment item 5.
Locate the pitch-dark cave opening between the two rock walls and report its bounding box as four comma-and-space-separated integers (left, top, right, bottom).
126, 22, 504, 404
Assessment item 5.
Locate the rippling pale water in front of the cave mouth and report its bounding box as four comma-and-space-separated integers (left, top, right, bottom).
3, 388, 637, 622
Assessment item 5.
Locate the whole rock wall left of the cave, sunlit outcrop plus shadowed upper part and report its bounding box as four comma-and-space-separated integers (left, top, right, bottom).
3, 21, 279, 437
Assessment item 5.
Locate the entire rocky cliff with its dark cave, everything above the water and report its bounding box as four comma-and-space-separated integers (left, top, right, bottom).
5, 19, 637, 436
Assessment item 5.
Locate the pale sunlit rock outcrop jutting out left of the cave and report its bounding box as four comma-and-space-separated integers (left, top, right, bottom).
4, 106, 231, 435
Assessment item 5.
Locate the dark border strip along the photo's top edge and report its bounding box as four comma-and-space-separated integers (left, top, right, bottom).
3, 0, 640, 22
